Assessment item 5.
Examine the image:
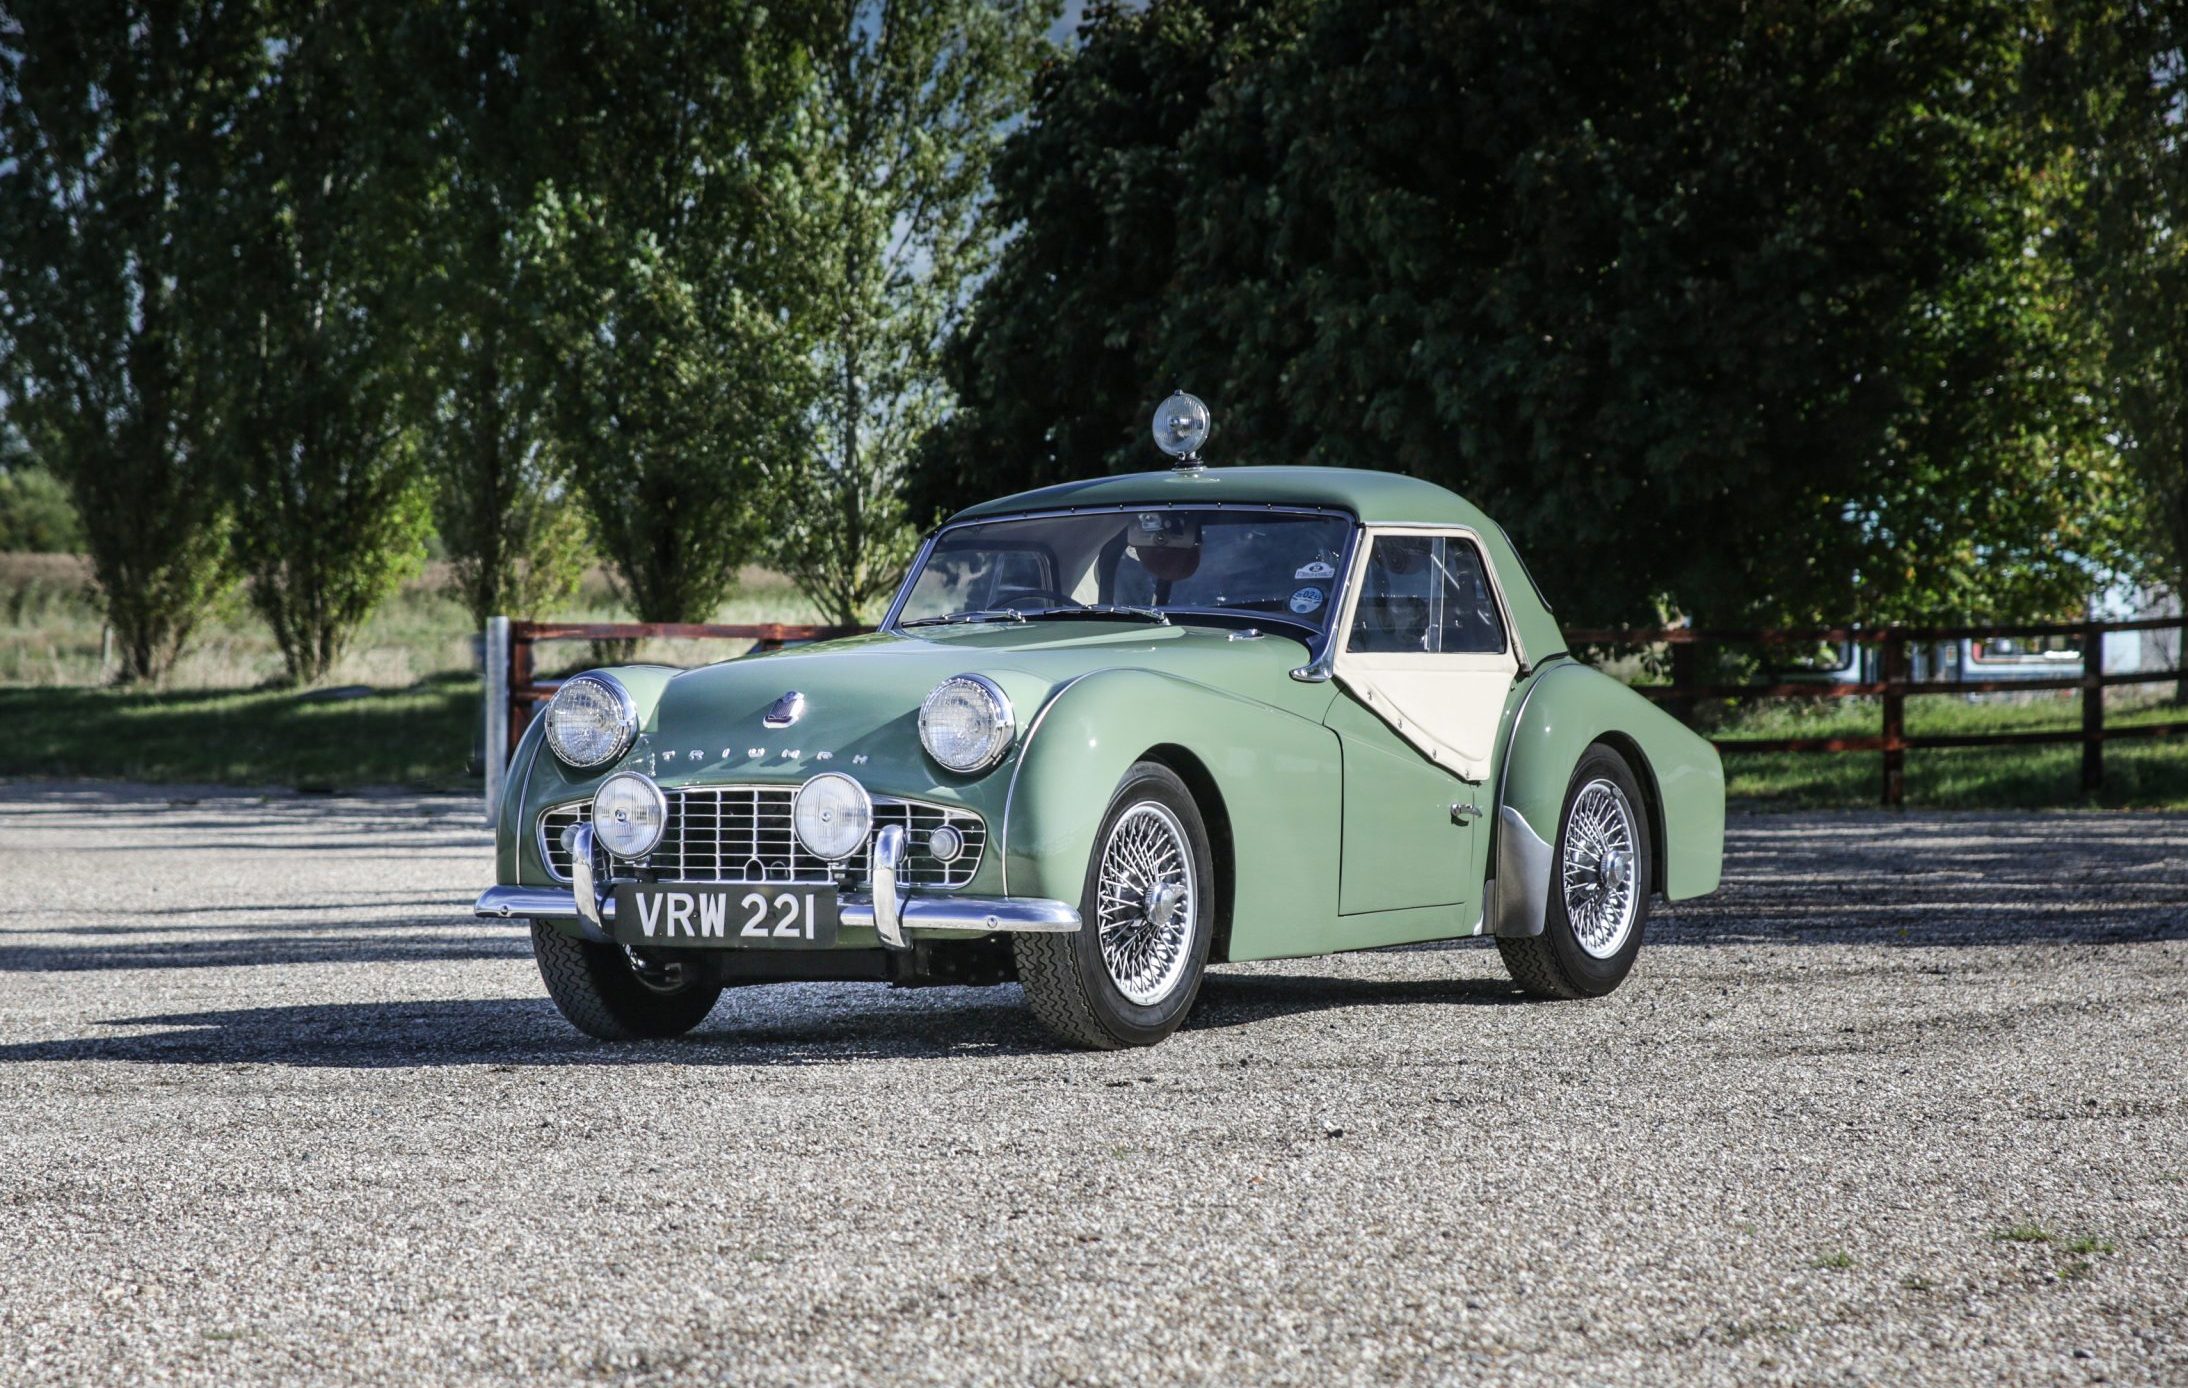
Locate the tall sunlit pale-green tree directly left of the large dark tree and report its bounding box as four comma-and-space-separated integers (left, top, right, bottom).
768, 0, 1057, 622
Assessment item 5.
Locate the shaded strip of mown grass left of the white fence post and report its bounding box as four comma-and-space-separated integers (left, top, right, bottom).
0, 674, 479, 790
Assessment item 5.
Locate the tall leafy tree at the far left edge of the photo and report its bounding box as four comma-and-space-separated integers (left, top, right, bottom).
0, 0, 267, 679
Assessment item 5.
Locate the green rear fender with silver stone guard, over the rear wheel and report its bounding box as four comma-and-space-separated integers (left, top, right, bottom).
1490, 661, 1724, 935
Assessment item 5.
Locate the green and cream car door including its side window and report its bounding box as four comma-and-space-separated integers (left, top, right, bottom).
1326, 530, 1518, 915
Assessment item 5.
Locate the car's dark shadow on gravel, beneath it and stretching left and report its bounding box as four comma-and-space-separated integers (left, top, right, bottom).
0, 974, 1525, 1068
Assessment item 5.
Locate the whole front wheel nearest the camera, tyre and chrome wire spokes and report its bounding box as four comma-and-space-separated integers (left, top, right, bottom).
1011, 762, 1214, 1051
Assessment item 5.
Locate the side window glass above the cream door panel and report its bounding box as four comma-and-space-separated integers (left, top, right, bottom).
1346, 534, 1505, 655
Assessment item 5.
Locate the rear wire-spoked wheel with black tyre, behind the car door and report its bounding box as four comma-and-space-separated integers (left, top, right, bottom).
1497, 747, 1656, 998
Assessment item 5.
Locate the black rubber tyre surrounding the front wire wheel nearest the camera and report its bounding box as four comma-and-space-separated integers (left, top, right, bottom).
1011, 762, 1217, 1051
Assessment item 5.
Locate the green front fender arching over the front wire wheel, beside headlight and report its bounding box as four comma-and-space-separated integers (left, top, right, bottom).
1002, 670, 1343, 959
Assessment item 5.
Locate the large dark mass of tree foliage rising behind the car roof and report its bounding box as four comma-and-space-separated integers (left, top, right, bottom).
915, 0, 2118, 622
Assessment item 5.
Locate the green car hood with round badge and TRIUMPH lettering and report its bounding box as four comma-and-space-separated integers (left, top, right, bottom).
626, 620, 1328, 799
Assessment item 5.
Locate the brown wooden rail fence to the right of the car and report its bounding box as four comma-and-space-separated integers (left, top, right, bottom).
1564, 617, 2188, 806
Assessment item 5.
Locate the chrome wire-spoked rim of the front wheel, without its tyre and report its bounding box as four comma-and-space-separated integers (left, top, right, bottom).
1096, 801, 1199, 1007
